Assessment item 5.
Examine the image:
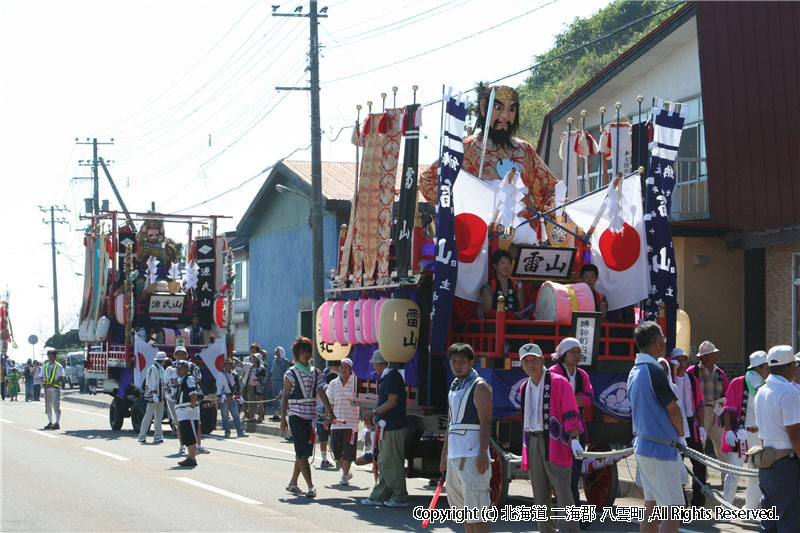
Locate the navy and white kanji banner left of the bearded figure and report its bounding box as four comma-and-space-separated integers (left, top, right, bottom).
430, 88, 469, 354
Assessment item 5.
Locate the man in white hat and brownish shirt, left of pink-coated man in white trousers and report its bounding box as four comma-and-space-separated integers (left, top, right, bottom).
686, 341, 729, 470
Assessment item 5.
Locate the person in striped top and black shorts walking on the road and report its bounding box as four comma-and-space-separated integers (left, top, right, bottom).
281, 337, 331, 498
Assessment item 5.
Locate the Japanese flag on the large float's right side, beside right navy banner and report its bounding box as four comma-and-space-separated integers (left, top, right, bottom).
564, 173, 650, 310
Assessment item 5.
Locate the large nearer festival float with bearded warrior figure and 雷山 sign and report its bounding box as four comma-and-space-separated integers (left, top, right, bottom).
316, 86, 688, 506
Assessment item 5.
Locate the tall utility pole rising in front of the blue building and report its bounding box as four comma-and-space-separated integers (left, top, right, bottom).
272, 0, 328, 368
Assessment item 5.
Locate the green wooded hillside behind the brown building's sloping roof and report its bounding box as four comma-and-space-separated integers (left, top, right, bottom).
517, 0, 683, 145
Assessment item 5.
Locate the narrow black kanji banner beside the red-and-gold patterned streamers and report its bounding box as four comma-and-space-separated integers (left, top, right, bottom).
394, 104, 419, 278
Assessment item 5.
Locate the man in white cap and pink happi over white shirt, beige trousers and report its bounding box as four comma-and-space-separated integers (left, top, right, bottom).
519, 343, 583, 533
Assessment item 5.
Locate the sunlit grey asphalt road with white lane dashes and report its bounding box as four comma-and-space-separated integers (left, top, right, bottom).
0, 401, 758, 532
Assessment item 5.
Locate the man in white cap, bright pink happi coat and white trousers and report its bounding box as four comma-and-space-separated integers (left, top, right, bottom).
722, 350, 769, 509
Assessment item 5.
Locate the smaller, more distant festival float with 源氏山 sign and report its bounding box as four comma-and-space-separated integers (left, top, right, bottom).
78, 211, 235, 433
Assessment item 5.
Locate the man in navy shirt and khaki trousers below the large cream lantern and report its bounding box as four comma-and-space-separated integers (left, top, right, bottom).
361, 350, 408, 507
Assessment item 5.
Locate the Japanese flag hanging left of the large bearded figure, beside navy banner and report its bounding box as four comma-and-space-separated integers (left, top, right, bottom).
453, 169, 496, 302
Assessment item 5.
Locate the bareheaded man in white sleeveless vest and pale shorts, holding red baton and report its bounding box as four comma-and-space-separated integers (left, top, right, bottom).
439, 342, 492, 533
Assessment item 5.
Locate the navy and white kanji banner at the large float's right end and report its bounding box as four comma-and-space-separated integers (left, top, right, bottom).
644, 100, 687, 352
